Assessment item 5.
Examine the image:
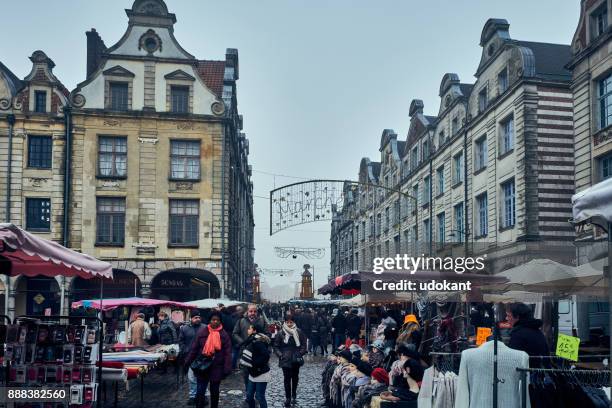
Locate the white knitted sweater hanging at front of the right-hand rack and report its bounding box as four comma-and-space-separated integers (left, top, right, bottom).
455, 341, 530, 408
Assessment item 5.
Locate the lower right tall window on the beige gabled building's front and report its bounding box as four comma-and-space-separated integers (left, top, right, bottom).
170, 200, 200, 246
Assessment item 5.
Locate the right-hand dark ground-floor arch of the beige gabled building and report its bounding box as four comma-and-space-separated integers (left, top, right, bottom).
151, 268, 221, 302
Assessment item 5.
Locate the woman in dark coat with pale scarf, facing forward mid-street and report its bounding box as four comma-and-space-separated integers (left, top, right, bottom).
274, 313, 307, 407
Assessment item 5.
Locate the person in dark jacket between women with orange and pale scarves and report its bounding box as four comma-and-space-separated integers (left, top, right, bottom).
240, 324, 271, 408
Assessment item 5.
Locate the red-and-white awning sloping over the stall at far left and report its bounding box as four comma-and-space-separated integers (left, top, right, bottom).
0, 224, 113, 279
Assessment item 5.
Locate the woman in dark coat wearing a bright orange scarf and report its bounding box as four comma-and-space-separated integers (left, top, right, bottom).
185, 311, 232, 408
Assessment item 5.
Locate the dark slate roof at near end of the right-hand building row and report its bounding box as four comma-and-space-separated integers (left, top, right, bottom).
518, 41, 572, 80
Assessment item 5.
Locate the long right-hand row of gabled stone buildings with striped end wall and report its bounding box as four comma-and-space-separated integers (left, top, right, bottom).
331, 19, 574, 276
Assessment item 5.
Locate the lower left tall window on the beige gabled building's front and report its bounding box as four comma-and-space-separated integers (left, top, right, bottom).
96, 197, 125, 245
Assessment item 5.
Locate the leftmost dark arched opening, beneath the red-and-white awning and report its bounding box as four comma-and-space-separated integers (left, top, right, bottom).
15, 276, 61, 316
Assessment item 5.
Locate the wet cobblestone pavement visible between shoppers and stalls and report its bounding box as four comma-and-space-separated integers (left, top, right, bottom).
104, 354, 325, 408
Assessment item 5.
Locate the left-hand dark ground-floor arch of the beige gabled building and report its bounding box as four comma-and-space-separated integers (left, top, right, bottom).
70, 269, 142, 302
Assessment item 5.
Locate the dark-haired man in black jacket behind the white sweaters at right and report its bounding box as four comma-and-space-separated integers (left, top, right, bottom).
506, 303, 549, 356
